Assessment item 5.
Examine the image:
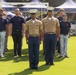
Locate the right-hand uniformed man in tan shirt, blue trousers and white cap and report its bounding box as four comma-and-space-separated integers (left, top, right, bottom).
42, 8, 60, 65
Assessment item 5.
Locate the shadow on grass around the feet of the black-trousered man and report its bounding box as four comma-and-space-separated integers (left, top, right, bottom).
0, 49, 28, 61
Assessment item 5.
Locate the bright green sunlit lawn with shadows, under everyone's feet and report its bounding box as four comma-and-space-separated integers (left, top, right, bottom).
0, 36, 76, 75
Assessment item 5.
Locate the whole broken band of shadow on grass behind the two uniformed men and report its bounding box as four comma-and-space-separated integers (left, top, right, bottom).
0, 49, 64, 63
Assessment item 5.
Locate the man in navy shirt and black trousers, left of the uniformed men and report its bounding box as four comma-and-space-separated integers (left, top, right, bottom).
10, 9, 25, 57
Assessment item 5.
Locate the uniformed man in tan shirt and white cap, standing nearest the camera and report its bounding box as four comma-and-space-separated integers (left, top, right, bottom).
25, 9, 43, 69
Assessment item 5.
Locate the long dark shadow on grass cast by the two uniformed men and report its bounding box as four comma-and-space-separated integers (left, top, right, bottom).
8, 65, 51, 75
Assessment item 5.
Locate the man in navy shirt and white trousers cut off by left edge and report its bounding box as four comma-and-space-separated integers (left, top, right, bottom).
0, 8, 8, 57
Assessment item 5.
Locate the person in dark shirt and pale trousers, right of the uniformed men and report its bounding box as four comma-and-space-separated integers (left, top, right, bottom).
60, 14, 71, 57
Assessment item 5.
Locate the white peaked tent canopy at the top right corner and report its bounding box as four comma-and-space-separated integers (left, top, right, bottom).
55, 0, 76, 13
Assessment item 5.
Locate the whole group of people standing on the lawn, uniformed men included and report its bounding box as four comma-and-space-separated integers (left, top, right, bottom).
0, 8, 71, 69
